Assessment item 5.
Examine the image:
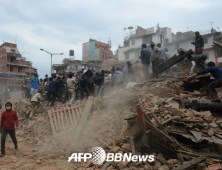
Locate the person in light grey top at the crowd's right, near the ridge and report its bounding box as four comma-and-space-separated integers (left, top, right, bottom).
112, 67, 125, 90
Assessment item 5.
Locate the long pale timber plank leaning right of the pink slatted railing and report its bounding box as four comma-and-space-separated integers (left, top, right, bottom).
74, 96, 93, 141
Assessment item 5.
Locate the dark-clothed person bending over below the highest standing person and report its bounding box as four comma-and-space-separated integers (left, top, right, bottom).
190, 55, 207, 75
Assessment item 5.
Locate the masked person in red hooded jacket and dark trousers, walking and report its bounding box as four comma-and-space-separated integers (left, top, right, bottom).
0, 101, 19, 157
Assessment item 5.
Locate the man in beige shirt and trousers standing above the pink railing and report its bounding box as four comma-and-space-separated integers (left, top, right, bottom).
67, 74, 77, 105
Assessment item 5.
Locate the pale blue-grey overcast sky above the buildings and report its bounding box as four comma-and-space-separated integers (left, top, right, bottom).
0, 0, 222, 78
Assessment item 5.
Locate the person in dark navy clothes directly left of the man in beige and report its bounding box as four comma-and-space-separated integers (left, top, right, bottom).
49, 77, 65, 107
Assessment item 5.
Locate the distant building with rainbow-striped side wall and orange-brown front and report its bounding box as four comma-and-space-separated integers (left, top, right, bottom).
82, 39, 113, 62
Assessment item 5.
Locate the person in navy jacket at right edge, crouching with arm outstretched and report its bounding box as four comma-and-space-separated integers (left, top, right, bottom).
188, 61, 222, 102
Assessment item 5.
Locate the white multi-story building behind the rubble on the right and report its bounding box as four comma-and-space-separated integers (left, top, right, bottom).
116, 26, 222, 66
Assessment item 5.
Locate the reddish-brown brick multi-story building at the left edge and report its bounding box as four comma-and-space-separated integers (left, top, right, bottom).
0, 42, 37, 91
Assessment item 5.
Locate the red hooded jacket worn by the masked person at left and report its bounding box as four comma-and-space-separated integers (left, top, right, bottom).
0, 109, 19, 129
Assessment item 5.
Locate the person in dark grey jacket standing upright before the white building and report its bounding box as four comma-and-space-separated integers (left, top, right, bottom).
139, 44, 151, 80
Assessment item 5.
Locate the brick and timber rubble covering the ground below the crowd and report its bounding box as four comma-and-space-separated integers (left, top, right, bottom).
0, 62, 222, 170
